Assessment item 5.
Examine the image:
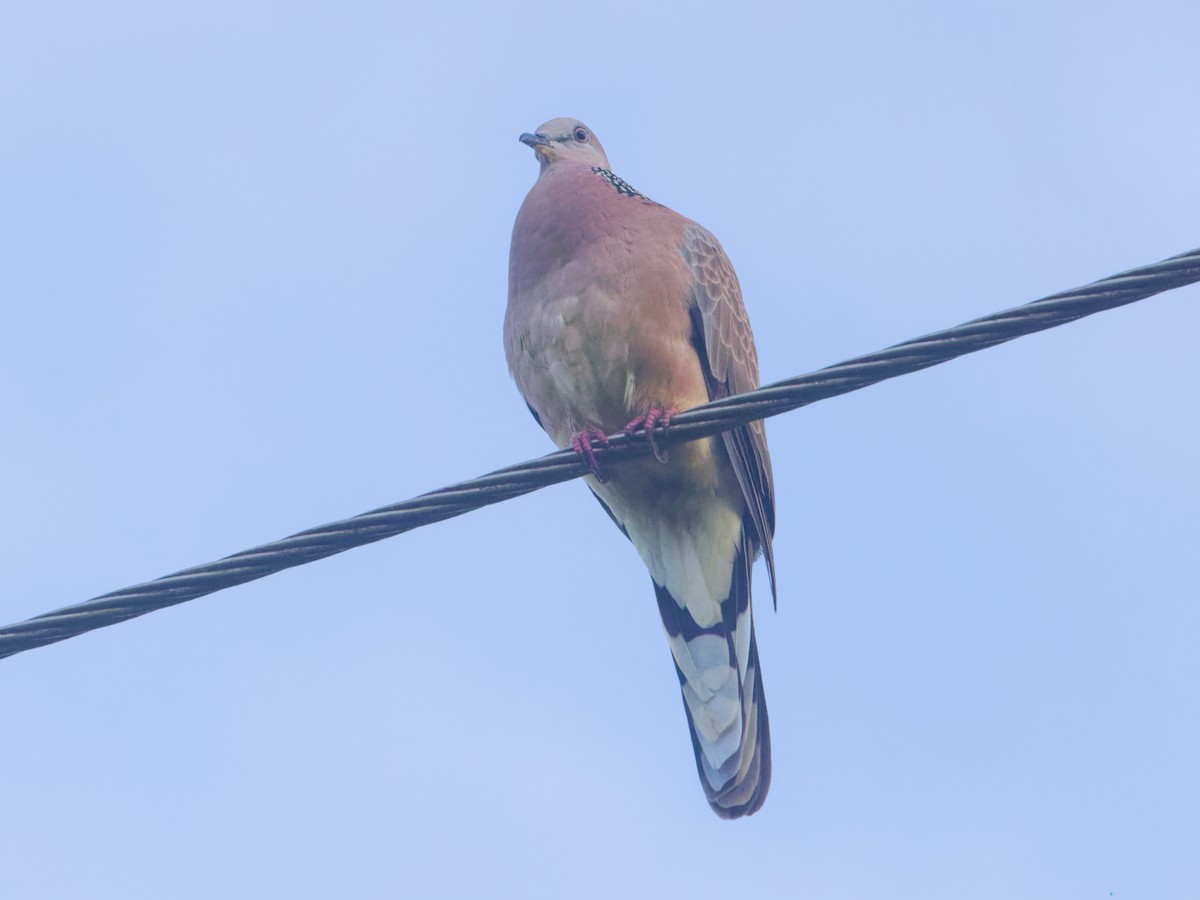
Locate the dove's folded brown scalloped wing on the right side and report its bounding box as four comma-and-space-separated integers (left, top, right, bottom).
683, 222, 775, 607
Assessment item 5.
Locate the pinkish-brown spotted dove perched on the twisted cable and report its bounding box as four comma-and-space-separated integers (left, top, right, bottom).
504, 119, 775, 818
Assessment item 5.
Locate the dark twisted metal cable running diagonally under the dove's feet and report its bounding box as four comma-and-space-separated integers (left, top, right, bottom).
0, 250, 1200, 659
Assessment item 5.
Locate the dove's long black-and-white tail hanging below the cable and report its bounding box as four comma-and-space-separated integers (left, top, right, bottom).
654, 534, 770, 818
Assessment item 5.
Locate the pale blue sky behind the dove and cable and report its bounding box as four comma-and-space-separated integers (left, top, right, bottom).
0, 0, 1200, 900
